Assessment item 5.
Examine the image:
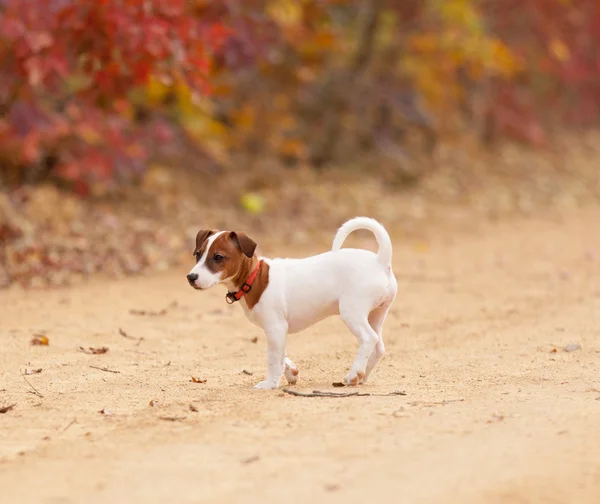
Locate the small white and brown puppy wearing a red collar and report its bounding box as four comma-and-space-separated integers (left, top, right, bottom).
187, 217, 398, 389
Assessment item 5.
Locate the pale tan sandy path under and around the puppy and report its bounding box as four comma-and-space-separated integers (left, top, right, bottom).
0, 208, 600, 504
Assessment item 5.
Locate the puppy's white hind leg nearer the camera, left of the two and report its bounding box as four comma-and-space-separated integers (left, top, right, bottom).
340, 301, 379, 385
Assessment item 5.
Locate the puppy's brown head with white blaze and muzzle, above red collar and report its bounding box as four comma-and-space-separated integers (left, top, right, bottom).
187, 229, 256, 289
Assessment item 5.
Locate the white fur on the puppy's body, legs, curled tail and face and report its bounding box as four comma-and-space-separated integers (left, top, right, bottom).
192, 217, 398, 389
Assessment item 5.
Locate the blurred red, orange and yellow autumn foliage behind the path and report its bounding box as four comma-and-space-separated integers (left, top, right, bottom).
0, 0, 600, 195
